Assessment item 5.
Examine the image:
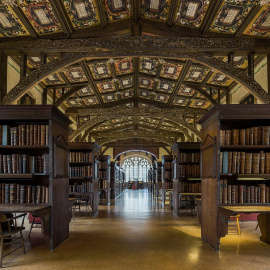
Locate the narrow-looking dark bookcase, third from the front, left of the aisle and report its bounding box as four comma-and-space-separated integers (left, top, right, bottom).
98, 155, 111, 205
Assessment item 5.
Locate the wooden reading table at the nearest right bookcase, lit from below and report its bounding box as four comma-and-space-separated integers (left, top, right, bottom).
219, 204, 270, 244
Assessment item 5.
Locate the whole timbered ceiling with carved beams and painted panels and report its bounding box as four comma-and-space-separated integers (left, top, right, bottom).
0, 0, 270, 145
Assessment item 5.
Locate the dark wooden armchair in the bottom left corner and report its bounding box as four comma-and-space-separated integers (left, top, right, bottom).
0, 213, 26, 268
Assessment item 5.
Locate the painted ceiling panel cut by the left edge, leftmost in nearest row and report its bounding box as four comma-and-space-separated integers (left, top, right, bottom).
0, 4, 29, 37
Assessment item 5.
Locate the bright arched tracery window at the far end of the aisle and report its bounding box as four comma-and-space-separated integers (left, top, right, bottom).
122, 157, 150, 182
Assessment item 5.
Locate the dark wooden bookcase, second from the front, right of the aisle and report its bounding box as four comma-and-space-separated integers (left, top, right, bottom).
172, 142, 201, 215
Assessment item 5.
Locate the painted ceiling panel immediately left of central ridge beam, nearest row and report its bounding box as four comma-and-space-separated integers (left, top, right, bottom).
105, 0, 131, 22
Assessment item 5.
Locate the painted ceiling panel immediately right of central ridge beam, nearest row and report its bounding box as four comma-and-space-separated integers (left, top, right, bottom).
140, 0, 170, 21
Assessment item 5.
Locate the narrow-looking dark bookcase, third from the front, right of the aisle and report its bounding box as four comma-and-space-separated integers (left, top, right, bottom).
161, 155, 173, 205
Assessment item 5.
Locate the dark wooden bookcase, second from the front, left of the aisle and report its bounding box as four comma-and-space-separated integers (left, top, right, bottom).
69, 142, 100, 213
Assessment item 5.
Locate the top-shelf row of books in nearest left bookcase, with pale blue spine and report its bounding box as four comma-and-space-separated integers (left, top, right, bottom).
0, 124, 49, 145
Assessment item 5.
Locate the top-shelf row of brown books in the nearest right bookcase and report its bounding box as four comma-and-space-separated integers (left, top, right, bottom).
220, 126, 270, 145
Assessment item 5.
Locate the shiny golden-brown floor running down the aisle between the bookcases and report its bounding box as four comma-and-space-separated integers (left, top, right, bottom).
3, 190, 270, 270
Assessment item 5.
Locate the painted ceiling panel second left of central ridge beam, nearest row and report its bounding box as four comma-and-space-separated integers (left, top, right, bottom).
62, 0, 100, 28
